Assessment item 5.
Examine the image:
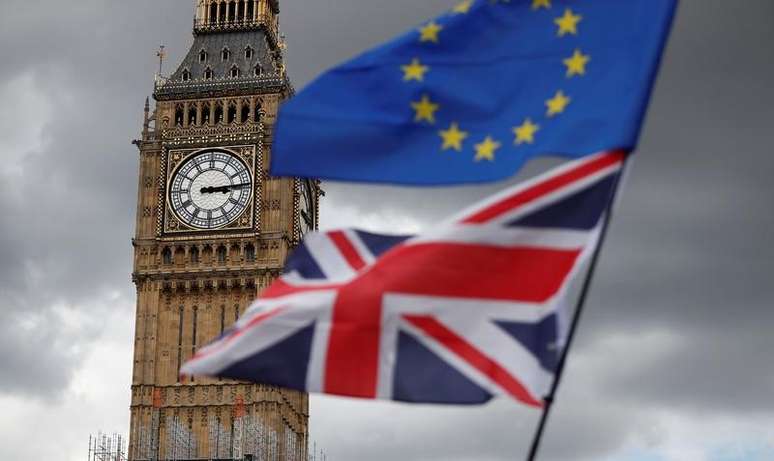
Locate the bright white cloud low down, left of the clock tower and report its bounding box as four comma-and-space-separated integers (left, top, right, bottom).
0, 296, 134, 461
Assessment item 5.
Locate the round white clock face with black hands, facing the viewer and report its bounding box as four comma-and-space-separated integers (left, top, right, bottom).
169, 149, 253, 229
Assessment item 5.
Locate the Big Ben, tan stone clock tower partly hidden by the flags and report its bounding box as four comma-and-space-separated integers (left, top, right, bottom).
129, 0, 319, 461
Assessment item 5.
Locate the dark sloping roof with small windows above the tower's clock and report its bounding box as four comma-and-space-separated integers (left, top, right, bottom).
155, 29, 285, 99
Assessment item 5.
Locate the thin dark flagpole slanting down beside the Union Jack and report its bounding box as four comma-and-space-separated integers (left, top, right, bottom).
527, 154, 629, 461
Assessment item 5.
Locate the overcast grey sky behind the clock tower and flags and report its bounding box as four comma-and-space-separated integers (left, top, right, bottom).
0, 0, 774, 461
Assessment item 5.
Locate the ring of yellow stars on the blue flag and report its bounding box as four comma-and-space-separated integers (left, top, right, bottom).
400, 0, 591, 162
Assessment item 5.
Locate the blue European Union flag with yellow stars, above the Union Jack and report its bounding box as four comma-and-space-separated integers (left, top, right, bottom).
271, 0, 676, 185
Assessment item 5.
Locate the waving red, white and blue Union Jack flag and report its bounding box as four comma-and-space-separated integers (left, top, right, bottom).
181, 152, 625, 407
